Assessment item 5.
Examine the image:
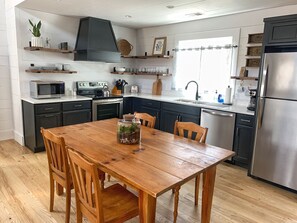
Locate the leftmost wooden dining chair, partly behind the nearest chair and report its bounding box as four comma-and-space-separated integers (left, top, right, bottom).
41, 128, 73, 223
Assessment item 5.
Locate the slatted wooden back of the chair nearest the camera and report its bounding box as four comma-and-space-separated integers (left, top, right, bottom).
67, 148, 104, 222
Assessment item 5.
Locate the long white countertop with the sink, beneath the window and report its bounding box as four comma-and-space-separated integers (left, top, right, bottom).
124, 93, 255, 115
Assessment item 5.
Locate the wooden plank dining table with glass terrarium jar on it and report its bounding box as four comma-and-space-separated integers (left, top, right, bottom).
49, 119, 234, 223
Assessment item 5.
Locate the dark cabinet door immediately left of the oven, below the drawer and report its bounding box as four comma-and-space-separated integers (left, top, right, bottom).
63, 109, 92, 125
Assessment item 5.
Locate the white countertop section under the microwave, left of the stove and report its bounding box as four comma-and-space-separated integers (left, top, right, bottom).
21, 95, 92, 104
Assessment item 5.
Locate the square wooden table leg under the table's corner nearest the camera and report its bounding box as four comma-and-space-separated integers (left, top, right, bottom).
139, 191, 157, 223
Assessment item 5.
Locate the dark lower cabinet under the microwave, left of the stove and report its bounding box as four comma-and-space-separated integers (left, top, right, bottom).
22, 100, 92, 152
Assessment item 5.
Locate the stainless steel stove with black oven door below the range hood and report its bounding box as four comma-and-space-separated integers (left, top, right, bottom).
76, 81, 123, 121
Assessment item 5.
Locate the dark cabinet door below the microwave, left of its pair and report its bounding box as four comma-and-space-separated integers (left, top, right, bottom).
34, 113, 62, 152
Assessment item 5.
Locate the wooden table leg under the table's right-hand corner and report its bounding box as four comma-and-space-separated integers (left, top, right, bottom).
201, 166, 217, 223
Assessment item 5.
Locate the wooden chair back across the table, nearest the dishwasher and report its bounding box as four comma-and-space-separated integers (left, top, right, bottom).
174, 120, 208, 143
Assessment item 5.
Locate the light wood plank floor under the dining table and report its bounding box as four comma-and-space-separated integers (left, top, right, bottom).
0, 140, 297, 223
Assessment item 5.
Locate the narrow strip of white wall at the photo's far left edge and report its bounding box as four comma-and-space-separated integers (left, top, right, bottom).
0, 0, 14, 140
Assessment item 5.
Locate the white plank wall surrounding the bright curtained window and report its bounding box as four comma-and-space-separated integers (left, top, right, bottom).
136, 5, 297, 104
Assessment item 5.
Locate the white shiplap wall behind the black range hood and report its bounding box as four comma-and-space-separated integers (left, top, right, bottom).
12, 8, 136, 143
